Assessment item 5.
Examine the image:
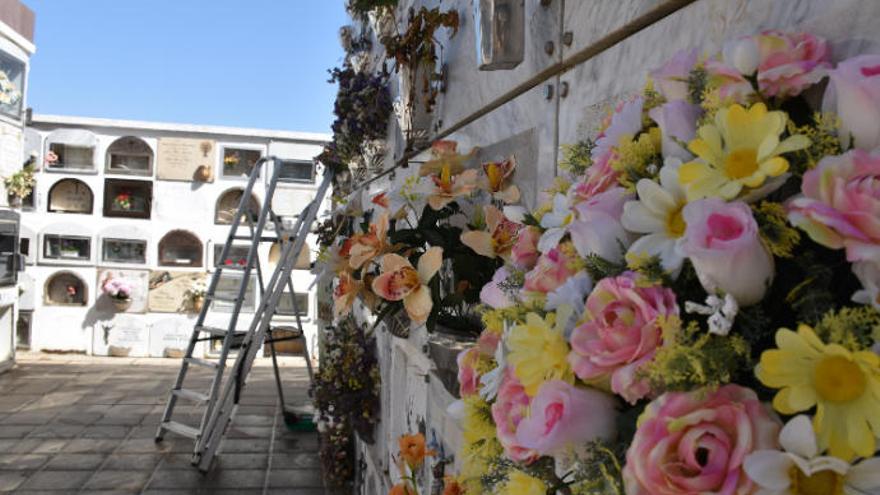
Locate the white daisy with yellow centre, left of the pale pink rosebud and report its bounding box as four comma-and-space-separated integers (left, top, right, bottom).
620, 158, 687, 277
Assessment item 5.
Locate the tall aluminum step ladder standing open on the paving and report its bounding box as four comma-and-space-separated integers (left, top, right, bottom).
156, 158, 331, 472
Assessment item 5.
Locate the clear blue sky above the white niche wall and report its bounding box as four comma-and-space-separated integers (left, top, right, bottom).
23, 0, 346, 132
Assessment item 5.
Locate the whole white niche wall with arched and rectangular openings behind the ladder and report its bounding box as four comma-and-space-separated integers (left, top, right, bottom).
17, 115, 329, 357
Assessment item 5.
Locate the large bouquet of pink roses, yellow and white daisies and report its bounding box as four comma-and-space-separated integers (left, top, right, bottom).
444, 31, 880, 495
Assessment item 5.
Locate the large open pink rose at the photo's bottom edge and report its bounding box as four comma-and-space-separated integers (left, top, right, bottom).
623, 385, 780, 495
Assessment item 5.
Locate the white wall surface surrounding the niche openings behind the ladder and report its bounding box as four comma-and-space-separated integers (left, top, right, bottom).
22, 116, 329, 362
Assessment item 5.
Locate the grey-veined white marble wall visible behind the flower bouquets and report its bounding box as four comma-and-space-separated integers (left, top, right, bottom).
340, 0, 880, 494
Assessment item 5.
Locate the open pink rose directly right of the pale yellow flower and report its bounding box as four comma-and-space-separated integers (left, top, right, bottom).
568, 272, 678, 404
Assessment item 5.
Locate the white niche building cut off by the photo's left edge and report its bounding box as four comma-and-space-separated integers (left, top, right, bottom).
0, 0, 36, 372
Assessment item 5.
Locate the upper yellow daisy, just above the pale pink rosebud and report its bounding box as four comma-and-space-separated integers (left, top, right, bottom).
678, 103, 810, 201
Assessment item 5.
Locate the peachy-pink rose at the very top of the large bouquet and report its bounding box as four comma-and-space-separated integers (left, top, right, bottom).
706, 31, 831, 100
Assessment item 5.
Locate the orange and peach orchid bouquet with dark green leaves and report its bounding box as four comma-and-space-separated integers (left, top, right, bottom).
321, 141, 520, 335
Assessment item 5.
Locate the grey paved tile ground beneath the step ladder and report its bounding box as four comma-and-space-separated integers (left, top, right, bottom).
0, 354, 334, 495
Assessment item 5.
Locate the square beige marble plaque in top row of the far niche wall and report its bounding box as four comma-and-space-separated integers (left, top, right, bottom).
157, 138, 217, 182
